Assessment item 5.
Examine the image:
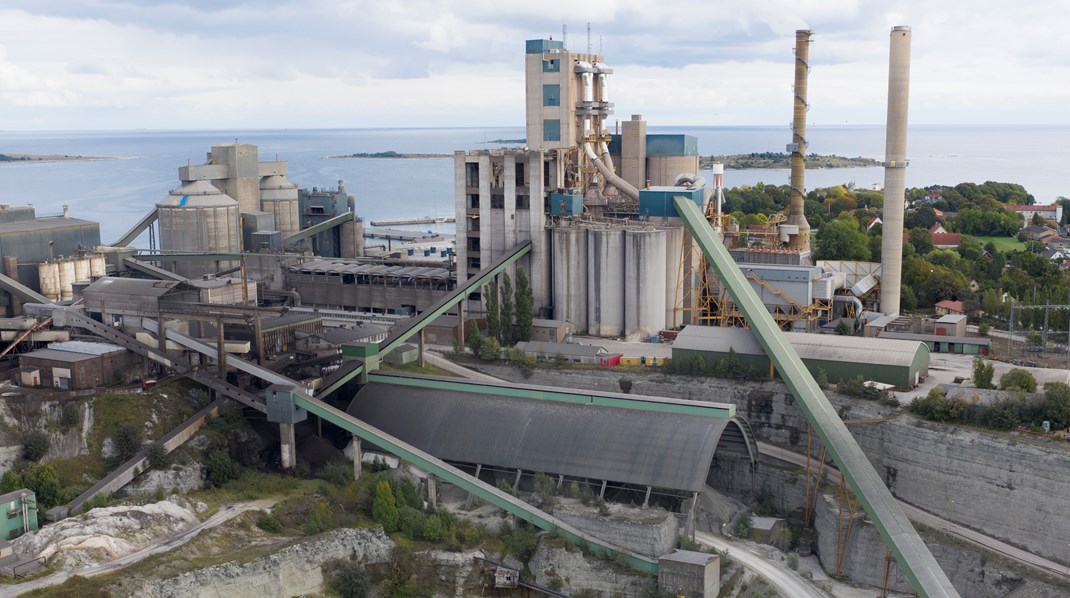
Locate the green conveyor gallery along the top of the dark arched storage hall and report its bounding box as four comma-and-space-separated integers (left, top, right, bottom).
368, 373, 735, 419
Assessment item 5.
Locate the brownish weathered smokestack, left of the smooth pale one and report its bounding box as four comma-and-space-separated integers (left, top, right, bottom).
784, 29, 812, 251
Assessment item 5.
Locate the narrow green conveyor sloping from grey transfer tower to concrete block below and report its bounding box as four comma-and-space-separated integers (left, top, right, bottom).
294, 395, 658, 576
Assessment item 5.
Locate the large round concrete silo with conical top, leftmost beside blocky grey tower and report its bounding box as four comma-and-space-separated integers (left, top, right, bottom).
156, 181, 241, 278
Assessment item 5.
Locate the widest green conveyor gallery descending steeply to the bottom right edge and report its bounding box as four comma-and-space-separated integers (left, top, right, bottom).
673, 197, 959, 598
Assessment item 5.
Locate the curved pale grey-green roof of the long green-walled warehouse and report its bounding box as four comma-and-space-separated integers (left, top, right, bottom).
673, 326, 928, 367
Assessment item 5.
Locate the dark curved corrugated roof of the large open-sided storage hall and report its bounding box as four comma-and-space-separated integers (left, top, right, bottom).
349, 382, 736, 491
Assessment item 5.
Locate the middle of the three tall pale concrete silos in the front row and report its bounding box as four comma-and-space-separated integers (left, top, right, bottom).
587, 229, 624, 337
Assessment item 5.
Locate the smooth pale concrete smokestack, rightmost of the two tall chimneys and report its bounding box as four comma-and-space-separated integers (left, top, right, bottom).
881, 26, 911, 316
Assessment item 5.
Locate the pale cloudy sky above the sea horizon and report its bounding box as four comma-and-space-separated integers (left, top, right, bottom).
0, 0, 1070, 129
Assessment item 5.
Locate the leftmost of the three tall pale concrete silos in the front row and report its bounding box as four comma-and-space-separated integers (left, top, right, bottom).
552, 228, 587, 332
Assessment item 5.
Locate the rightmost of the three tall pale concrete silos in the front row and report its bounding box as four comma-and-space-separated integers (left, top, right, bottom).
624, 230, 675, 339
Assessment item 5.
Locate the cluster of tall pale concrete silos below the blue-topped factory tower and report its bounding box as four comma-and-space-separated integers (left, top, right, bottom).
551, 221, 683, 338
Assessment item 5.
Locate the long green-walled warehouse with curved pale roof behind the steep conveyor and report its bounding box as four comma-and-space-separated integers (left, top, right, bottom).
672, 326, 929, 388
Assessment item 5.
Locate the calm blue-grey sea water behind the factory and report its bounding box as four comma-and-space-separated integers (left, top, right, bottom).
0, 125, 1070, 243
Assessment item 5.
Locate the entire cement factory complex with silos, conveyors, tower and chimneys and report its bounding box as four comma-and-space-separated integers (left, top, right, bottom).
0, 27, 1014, 596
